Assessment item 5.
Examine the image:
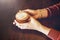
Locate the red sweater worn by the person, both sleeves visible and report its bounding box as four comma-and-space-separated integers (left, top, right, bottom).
47, 3, 60, 40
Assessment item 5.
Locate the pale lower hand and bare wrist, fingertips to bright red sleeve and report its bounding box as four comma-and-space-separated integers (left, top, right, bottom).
13, 17, 51, 35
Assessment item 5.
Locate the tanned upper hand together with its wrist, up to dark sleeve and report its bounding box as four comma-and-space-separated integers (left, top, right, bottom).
22, 9, 48, 19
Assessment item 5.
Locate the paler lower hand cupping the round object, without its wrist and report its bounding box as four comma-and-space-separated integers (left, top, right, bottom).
13, 17, 42, 30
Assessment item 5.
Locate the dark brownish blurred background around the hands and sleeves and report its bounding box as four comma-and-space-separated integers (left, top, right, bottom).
0, 0, 60, 40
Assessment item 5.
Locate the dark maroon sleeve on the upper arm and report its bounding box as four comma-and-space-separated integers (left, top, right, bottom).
46, 3, 60, 17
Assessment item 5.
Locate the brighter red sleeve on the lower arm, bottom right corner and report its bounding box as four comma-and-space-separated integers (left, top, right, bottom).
48, 29, 60, 40
